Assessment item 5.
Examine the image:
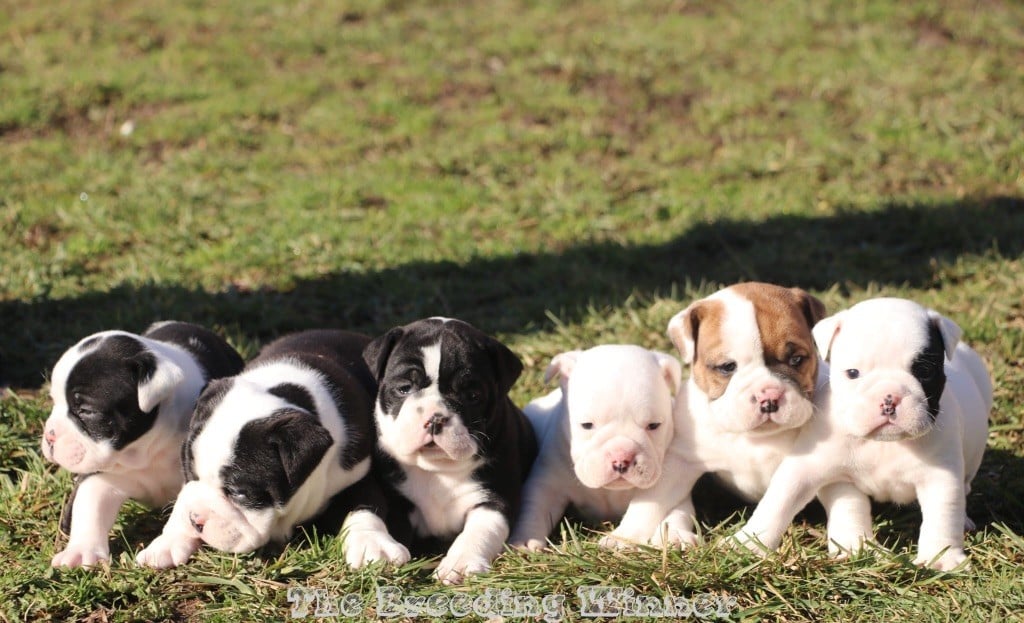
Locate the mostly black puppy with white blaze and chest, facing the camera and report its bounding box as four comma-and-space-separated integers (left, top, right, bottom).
364, 318, 537, 584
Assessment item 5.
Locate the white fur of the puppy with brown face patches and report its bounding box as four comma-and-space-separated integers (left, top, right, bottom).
651, 288, 826, 546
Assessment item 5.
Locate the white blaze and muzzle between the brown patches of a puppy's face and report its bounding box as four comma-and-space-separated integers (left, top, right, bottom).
698, 289, 813, 435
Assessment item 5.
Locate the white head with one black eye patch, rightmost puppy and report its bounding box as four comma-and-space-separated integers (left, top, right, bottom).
814, 298, 961, 441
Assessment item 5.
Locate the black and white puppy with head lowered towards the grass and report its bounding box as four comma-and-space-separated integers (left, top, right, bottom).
136, 330, 409, 569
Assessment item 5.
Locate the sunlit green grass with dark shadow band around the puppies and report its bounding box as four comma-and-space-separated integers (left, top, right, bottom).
0, 0, 1024, 621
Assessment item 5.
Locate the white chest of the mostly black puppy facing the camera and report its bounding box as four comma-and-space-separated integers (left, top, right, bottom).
398, 467, 487, 536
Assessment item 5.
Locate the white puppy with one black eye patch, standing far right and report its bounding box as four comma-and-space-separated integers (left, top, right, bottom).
735, 298, 992, 570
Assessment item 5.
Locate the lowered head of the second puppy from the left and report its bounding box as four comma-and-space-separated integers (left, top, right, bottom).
175, 365, 334, 552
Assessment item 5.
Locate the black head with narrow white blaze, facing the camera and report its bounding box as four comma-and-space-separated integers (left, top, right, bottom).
364, 318, 522, 471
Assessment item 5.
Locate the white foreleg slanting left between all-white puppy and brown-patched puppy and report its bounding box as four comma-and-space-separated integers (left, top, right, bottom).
599, 468, 700, 549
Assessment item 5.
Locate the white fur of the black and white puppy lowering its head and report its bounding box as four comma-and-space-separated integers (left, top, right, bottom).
136, 361, 370, 568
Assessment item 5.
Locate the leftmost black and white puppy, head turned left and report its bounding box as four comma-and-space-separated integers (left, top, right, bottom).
42, 322, 243, 567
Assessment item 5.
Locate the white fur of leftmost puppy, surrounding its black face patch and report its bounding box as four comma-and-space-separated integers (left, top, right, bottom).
41, 331, 205, 567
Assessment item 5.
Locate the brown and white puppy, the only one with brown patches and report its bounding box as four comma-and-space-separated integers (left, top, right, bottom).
624, 283, 825, 546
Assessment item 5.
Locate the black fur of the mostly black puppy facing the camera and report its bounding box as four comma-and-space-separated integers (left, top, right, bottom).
364, 319, 538, 537
